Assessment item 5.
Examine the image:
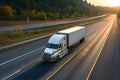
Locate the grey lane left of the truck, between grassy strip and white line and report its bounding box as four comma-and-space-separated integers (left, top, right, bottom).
0, 37, 49, 65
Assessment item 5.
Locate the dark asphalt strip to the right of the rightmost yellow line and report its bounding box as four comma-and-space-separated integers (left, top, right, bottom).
89, 15, 120, 80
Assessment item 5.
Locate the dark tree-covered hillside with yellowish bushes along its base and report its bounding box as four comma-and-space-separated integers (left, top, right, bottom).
0, 0, 110, 20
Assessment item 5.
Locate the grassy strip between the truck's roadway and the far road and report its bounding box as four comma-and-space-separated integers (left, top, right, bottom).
0, 20, 100, 47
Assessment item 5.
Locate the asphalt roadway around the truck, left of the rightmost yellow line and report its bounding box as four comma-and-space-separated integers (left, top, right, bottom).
0, 15, 116, 80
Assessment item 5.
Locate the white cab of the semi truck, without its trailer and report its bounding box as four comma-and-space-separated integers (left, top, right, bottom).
43, 34, 68, 62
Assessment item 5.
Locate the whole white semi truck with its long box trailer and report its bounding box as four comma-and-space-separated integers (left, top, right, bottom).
43, 26, 86, 62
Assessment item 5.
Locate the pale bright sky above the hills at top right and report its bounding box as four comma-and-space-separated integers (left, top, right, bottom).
87, 0, 120, 6
